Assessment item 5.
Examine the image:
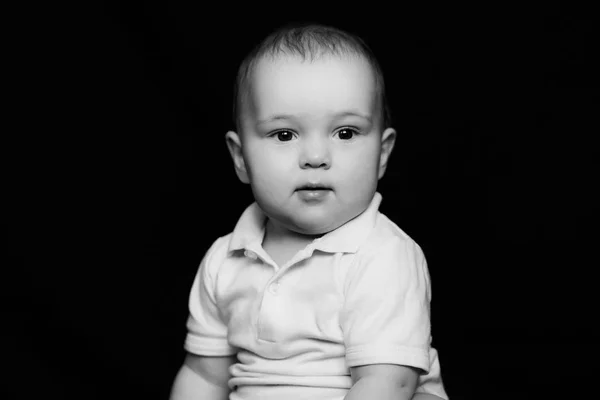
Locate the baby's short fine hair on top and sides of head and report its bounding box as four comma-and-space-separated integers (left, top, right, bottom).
233, 23, 392, 132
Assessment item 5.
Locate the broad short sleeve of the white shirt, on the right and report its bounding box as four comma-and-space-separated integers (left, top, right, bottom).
340, 236, 431, 374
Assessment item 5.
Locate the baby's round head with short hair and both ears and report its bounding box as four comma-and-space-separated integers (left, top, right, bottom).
226, 25, 396, 236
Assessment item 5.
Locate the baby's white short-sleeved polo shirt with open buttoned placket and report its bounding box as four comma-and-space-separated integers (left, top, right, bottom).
185, 193, 448, 400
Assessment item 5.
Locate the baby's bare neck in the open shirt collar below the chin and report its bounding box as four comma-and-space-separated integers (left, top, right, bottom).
262, 219, 318, 267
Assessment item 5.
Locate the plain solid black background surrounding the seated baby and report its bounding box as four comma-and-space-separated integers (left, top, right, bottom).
7, 1, 598, 399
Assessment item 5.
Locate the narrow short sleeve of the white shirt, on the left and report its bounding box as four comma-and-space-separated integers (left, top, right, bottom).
184, 240, 236, 356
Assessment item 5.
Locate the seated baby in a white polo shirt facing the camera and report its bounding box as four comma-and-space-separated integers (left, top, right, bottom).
171, 25, 448, 400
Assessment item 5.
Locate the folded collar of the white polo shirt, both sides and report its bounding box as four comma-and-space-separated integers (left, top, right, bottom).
229, 192, 382, 253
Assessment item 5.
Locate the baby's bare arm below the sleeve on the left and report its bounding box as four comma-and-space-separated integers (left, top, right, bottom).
170, 353, 236, 400
